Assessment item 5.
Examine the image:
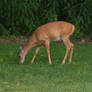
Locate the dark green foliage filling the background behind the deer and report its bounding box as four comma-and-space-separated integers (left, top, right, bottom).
0, 0, 92, 39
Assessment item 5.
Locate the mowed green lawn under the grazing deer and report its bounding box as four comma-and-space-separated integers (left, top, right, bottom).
0, 42, 92, 92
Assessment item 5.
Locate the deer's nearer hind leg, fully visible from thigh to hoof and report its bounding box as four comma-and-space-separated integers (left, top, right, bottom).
62, 38, 72, 64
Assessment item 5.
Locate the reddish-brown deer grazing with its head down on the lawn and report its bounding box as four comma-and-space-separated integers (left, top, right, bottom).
18, 21, 75, 64
